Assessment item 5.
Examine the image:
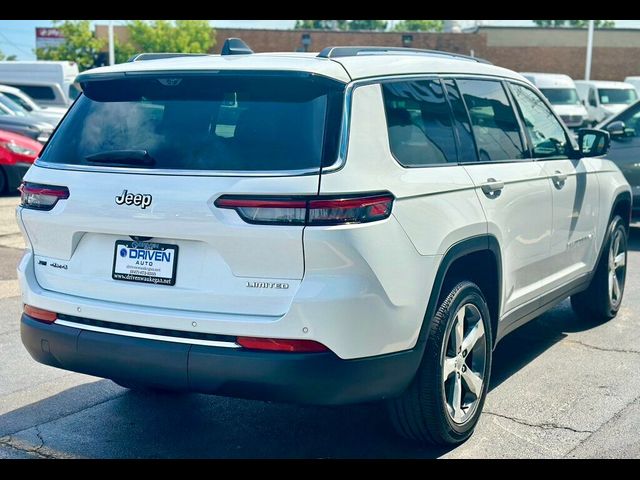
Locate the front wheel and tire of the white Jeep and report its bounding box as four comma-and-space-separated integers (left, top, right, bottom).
571, 215, 628, 323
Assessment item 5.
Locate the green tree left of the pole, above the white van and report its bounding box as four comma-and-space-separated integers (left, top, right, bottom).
36, 20, 107, 71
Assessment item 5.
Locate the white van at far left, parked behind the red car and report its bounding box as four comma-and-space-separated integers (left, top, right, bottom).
0, 61, 80, 108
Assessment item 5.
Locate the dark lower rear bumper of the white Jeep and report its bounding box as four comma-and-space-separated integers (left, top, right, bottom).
20, 314, 421, 405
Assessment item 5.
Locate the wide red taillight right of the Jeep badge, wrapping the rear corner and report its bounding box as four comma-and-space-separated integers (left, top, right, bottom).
214, 193, 394, 226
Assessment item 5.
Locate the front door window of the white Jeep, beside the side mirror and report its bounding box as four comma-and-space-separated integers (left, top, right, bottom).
510, 84, 568, 158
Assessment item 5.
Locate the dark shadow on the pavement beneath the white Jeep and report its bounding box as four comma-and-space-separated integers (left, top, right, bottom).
0, 302, 604, 458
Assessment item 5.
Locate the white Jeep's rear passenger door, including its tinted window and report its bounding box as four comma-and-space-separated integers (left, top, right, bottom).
456, 79, 552, 312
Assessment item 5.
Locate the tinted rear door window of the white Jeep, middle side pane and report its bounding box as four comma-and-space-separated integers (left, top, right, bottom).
457, 80, 525, 162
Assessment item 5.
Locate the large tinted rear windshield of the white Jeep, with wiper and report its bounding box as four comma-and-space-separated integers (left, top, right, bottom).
42, 73, 344, 171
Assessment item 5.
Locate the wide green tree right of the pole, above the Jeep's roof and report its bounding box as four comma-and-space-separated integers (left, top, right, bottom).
120, 20, 216, 53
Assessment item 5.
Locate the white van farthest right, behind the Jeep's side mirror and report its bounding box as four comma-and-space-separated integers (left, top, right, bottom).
575, 80, 638, 124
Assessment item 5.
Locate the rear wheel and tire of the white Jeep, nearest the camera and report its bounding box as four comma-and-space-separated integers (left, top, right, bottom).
388, 281, 493, 445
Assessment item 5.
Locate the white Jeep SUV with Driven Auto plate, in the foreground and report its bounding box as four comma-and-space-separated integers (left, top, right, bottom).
17, 40, 631, 444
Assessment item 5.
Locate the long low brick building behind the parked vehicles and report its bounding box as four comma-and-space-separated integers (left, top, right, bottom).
96, 25, 640, 80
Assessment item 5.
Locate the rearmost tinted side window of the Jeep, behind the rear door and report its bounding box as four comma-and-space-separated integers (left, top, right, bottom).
382, 80, 457, 167
